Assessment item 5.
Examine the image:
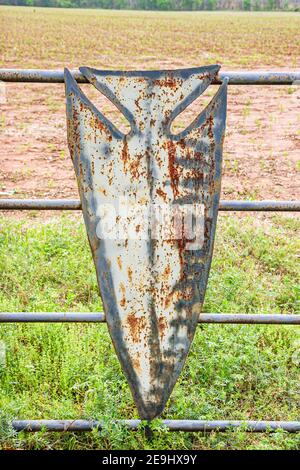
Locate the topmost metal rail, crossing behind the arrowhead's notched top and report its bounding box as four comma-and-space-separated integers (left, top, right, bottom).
0, 69, 300, 85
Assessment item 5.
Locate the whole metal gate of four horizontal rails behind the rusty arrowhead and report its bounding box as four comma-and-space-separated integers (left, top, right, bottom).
0, 69, 300, 432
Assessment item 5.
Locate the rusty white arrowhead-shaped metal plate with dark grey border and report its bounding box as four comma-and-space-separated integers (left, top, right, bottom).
65, 66, 227, 419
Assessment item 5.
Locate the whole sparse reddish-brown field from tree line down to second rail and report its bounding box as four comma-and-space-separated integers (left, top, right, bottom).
0, 7, 300, 200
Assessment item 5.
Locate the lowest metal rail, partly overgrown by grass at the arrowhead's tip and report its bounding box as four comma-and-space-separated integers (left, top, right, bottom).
12, 419, 300, 432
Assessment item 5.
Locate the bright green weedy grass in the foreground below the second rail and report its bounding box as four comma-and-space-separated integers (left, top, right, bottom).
0, 216, 300, 449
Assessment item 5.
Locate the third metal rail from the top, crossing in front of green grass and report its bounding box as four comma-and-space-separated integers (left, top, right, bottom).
0, 312, 300, 325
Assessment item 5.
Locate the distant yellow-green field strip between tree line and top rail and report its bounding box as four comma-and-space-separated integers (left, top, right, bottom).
0, 6, 300, 70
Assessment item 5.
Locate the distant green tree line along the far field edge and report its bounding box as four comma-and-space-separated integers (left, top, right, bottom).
0, 0, 300, 11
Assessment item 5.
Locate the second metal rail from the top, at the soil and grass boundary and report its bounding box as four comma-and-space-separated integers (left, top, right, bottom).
0, 199, 300, 212
